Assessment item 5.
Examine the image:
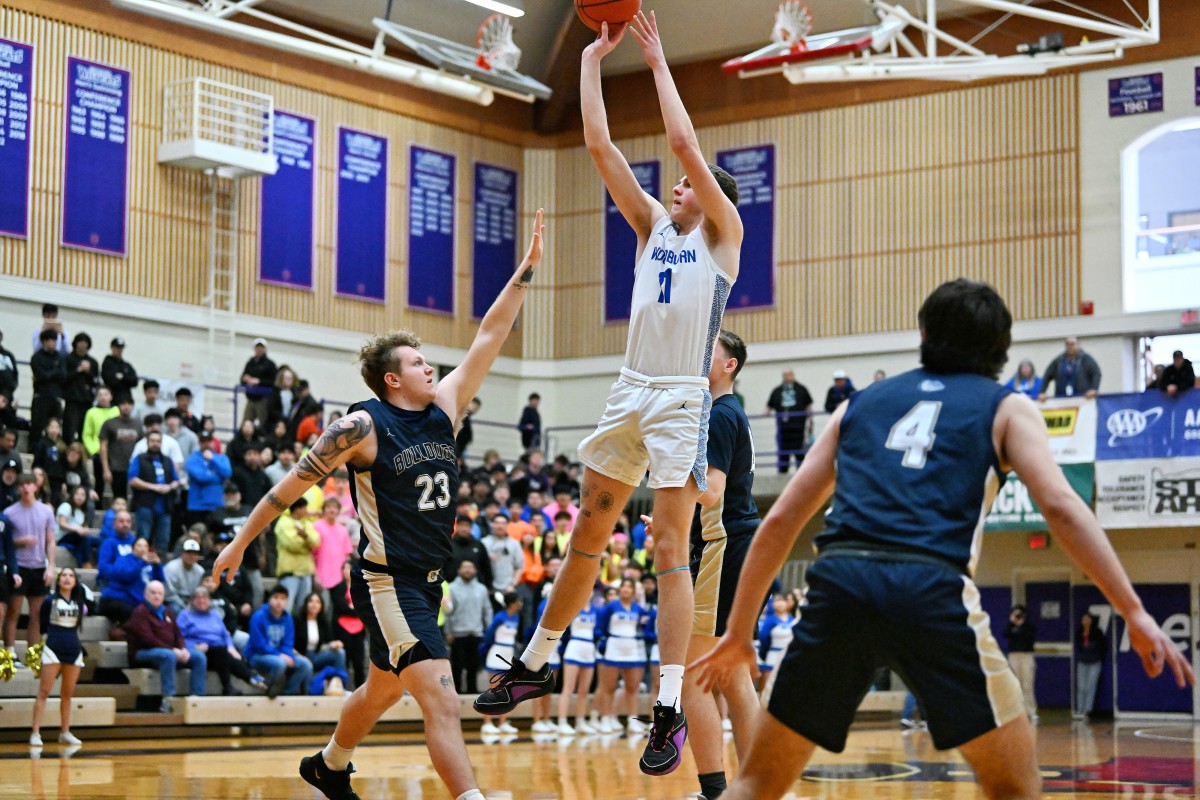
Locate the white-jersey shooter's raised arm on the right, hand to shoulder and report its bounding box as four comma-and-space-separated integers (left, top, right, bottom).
629, 11, 742, 253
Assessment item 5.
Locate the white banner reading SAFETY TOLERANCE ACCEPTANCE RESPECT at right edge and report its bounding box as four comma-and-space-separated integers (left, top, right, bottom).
1096, 458, 1200, 528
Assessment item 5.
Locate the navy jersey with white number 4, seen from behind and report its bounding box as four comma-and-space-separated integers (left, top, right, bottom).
816, 369, 1009, 572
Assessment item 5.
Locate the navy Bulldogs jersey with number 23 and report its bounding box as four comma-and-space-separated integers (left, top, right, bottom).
349, 399, 458, 573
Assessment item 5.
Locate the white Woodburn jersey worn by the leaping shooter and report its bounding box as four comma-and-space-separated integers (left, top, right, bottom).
625, 217, 733, 378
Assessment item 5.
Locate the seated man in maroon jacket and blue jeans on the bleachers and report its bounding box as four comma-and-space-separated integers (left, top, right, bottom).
125, 581, 208, 714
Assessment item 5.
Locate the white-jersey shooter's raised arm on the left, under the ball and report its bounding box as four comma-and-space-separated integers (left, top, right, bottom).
580, 23, 667, 241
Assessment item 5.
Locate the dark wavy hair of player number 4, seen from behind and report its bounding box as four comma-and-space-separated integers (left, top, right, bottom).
917, 278, 1013, 380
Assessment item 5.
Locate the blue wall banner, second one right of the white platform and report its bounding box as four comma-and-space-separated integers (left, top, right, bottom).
336, 126, 388, 302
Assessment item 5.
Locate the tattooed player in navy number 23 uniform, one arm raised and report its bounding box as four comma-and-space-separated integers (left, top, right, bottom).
212, 209, 542, 800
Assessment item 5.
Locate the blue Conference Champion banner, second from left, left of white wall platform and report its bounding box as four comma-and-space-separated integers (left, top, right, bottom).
62, 56, 131, 255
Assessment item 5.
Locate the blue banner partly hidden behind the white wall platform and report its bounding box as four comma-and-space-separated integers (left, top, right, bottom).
258, 109, 317, 289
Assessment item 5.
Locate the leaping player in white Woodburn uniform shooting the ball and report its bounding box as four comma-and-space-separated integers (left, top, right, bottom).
475, 12, 742, 775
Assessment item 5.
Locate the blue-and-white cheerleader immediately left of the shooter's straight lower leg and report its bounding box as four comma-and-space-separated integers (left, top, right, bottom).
596, 578, 649, 734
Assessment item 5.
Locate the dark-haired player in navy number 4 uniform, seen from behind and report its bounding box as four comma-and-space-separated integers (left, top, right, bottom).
696, 278, 1194, 800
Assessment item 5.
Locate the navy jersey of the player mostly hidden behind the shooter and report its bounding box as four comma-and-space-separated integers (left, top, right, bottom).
691, 395, 758, 547
